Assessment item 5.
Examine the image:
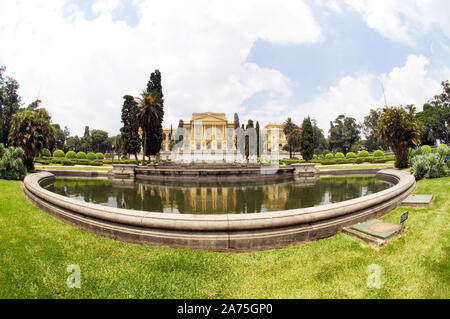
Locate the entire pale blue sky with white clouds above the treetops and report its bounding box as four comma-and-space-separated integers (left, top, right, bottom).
0, 0, 450, 135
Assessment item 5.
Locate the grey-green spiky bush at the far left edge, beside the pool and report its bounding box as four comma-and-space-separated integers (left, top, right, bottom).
0, 144, 27, 180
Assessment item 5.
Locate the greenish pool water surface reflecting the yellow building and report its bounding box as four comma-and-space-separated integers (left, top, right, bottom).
47, 176, 390, 214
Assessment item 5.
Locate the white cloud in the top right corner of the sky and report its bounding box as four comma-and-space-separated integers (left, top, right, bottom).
345, 0, 450, 46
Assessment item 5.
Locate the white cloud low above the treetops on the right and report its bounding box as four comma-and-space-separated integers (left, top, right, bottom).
284, 55, 444, 134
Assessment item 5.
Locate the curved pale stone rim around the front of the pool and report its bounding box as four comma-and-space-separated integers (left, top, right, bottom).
23, 169, 415, 251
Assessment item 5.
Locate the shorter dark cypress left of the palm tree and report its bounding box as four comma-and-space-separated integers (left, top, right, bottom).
120, 95, 142, 161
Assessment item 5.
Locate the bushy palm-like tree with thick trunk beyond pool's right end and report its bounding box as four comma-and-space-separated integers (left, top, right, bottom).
376, 104, 422, 168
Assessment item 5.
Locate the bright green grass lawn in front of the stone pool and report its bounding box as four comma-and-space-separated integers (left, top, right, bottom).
0, 178, 450, 298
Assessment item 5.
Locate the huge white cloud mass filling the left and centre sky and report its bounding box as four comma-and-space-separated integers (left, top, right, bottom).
0, 0, 321, 134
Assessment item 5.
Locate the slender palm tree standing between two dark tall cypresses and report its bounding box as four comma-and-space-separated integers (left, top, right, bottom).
138, 90, 164, 165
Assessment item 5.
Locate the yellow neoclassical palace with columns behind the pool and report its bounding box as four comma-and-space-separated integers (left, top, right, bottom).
161, 112, 287, 162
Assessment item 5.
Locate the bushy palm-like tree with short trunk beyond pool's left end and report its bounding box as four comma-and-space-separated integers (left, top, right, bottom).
8, 108, 55, 171
